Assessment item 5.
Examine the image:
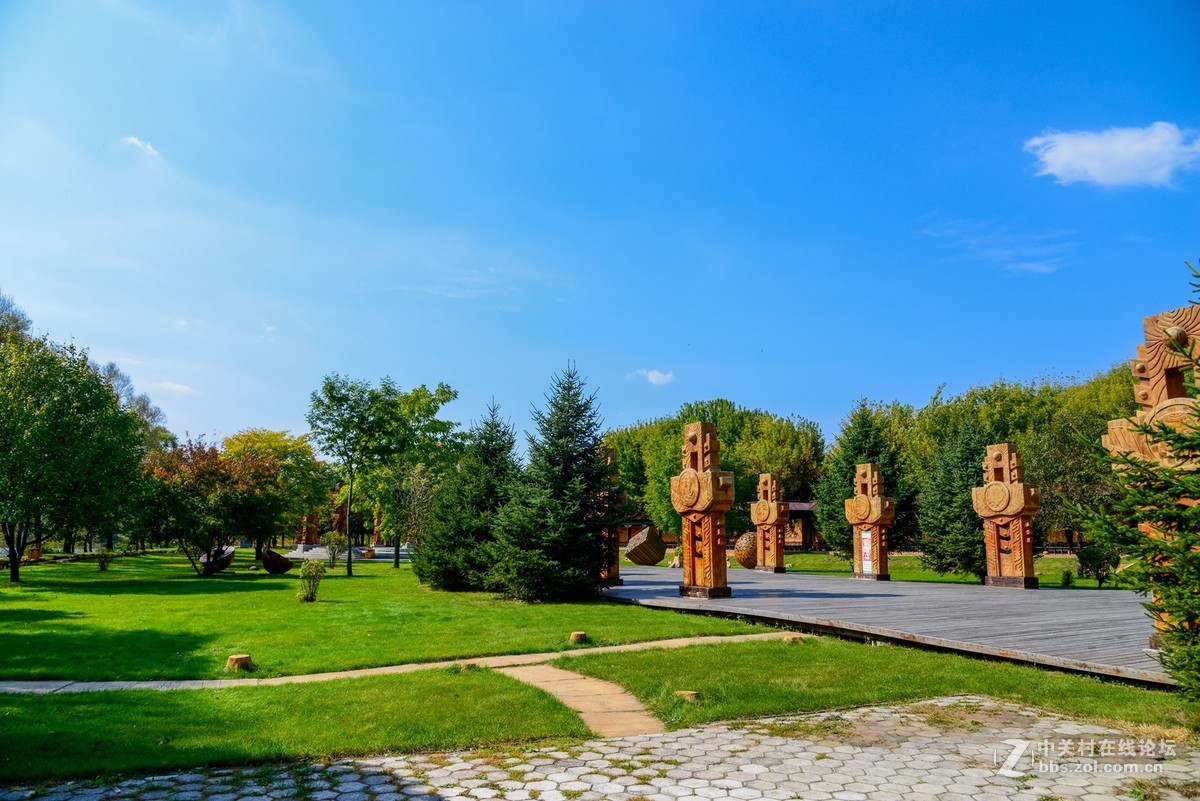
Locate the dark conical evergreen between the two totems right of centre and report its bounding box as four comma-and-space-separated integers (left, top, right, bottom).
919, 417, 988, 583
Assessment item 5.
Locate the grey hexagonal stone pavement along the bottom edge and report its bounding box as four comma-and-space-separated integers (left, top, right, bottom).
0, 697, 1200, 801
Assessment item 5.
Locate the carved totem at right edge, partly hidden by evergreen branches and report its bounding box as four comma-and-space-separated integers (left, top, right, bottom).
1102, 306, 1200, 649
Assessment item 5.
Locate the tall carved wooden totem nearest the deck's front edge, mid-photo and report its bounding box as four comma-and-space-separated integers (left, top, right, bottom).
671, 423, 733, 598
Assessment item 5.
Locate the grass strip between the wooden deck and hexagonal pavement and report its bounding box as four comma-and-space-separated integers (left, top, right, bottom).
556, 637, 1200, 731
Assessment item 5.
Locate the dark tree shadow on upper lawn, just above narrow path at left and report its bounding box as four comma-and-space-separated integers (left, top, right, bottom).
0, 628, 212, 681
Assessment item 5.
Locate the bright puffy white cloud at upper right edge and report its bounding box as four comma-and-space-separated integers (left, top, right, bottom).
1025, 122, 1200, 186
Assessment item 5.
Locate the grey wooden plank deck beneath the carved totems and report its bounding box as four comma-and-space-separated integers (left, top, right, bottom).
605, 567, 1174, 686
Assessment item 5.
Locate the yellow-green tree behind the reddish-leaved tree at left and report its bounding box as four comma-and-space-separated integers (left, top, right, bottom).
222, 428, 332, 559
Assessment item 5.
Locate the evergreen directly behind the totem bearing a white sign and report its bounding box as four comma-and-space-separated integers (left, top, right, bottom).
816, 398, 913, 559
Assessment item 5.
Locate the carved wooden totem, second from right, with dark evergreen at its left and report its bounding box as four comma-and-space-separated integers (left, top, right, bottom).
971, 442, 1040, 590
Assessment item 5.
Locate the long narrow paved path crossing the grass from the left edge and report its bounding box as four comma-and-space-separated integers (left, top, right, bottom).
0, 632, 796, 695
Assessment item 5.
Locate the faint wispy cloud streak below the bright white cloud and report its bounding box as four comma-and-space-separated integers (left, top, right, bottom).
922, 219, 1075, 273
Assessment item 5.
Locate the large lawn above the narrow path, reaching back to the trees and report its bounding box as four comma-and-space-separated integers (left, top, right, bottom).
0, 555, 764, 681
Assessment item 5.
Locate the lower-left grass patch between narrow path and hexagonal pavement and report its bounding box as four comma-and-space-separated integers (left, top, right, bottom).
0, 668, 589, 787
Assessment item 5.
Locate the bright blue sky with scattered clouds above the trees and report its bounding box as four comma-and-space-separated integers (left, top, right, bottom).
0, 0, 1200, 448
